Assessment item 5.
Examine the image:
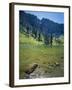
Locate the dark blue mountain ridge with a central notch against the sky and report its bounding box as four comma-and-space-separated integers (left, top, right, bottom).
19, 11, 64, 36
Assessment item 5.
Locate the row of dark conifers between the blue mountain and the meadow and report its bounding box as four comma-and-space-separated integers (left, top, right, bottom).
20, 26, 61, 47
